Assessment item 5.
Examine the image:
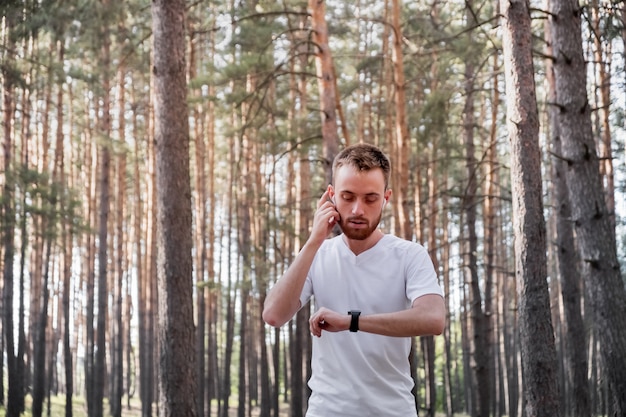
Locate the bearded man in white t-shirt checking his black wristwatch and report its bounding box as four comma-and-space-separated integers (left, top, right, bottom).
263, 144, 445, 417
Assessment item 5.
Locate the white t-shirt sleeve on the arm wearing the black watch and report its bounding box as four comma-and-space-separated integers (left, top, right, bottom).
406, 245, 443, 303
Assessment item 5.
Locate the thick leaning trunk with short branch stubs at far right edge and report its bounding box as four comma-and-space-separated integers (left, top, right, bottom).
549, 0, 626, 415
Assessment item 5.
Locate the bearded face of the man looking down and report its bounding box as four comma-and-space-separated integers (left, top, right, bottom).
331, 166, 391, 240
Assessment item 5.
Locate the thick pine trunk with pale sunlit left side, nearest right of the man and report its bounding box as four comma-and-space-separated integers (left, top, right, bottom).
500, 0, 560, 417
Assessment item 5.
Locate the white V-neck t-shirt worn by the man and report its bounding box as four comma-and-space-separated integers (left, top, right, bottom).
300, 235, 443, 417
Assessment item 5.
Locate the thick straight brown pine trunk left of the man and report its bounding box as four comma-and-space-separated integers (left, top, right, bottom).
152, 0, 197, 417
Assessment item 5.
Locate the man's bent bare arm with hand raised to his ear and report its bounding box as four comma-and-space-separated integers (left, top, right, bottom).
263, 186, 339, 327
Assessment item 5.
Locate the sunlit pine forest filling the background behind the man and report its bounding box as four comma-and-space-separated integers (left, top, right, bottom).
0, 0, 626, 417
